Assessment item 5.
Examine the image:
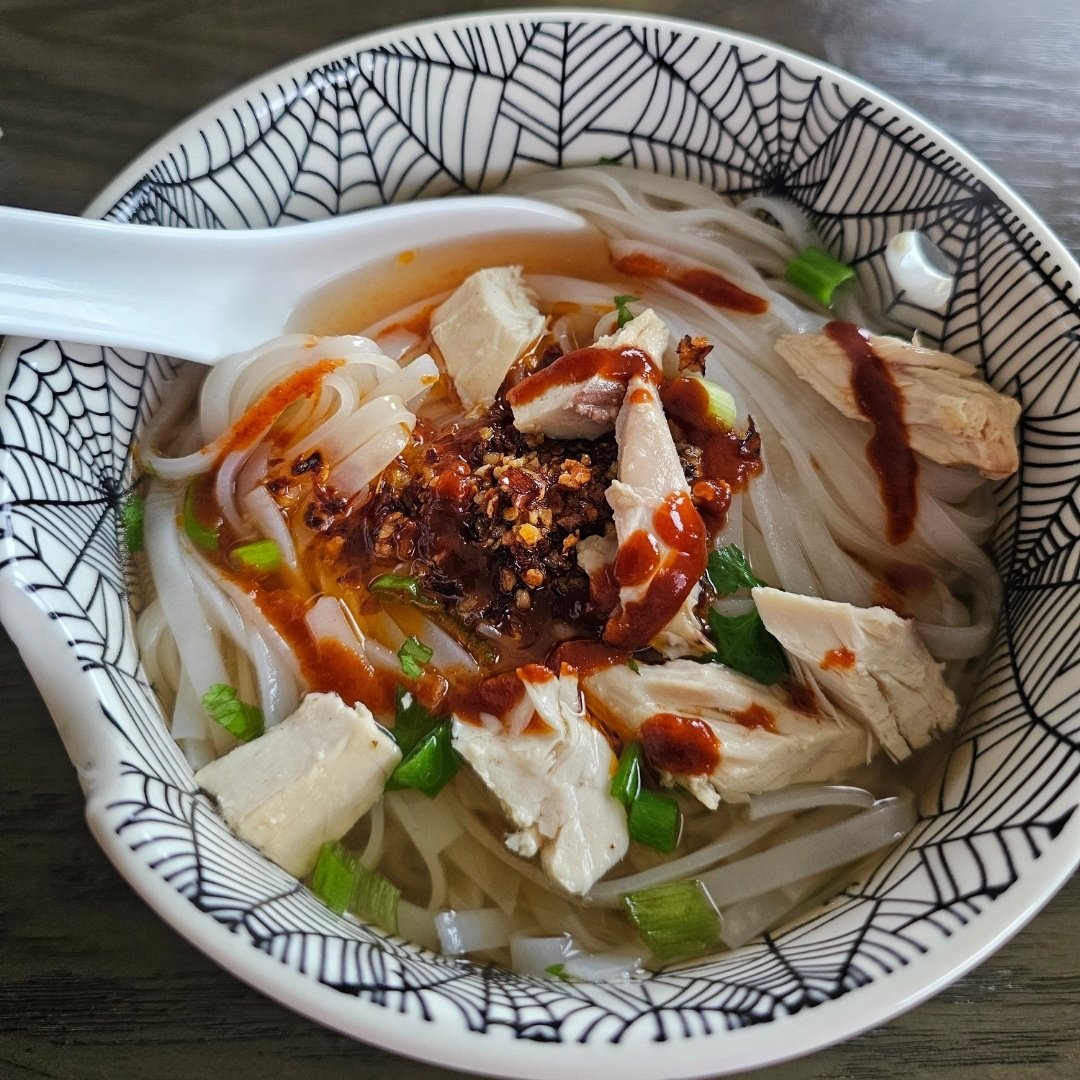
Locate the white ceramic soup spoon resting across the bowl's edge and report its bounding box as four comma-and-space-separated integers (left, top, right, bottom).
0, 195, 589, 364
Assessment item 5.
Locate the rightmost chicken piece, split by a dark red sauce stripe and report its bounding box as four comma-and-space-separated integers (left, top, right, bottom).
777, 332, 1021, 480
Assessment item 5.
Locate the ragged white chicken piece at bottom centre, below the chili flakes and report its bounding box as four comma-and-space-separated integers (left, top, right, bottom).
453, 666, 630, 896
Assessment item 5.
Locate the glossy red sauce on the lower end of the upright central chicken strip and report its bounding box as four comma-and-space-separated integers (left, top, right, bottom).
604, 491, 708, 650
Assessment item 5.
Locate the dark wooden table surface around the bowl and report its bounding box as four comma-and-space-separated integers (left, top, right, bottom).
0, 0, 1080, 1080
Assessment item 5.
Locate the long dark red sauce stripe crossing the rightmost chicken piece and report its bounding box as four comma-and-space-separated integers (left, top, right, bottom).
825, 322, 919, 544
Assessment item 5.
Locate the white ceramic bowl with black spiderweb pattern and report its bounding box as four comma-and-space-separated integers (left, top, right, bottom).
0, 11, 1080, 1080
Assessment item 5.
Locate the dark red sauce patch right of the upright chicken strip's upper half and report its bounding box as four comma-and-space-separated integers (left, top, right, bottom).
660, 378, 762, 530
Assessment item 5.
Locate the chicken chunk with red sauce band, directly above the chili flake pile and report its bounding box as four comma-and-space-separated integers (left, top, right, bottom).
507, 308, 669, 438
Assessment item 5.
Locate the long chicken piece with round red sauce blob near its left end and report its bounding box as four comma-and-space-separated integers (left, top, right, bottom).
582, 660, 872, 809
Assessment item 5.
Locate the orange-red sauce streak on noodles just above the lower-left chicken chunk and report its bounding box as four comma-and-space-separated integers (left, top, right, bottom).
251, 588, 397, 716
